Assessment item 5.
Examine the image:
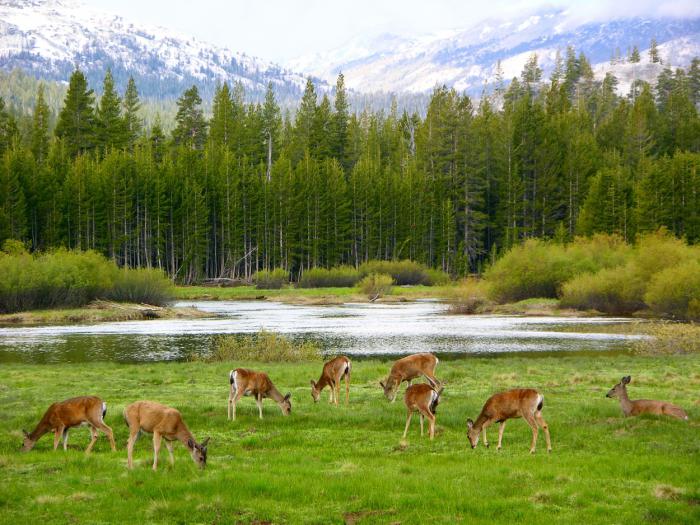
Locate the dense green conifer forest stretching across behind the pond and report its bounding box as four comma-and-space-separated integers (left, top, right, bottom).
0, 49, 700, 283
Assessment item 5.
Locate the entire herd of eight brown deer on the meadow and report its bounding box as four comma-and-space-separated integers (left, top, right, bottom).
22, 353, 688, 470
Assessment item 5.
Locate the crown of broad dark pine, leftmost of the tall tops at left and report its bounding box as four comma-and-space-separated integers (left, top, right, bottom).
55, 69, 95, 156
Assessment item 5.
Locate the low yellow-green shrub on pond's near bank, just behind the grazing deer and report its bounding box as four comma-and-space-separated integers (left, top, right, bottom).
201, 330, 322, 363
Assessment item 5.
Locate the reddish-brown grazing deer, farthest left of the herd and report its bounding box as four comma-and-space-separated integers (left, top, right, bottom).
22, 396, 117, 454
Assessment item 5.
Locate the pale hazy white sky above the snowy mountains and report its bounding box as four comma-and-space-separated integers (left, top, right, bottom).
83, 0, 700, 63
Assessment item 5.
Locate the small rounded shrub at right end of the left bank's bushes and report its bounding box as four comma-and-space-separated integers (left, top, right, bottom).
106, 268, 174, 306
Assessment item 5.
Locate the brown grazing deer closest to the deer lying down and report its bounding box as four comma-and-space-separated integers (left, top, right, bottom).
467, 388, 552, 454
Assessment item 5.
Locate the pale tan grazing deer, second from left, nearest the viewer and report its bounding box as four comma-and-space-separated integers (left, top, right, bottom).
124, 401, 209, 470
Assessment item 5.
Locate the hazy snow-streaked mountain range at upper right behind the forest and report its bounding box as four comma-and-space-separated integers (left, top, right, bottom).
287, 9, 700, 95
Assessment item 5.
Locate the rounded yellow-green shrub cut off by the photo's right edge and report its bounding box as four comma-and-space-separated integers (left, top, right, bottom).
644, 260, 700, 320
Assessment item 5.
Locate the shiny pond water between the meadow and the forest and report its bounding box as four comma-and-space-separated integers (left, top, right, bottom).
0, 301, 638, 363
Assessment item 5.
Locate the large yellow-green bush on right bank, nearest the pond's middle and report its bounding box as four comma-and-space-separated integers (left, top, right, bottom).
484, 235, 630, 302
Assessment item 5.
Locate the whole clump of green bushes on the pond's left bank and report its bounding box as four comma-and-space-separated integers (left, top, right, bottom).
0, 246, 170, 313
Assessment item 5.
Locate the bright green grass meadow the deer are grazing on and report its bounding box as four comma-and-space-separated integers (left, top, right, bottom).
0, 354, 700, 524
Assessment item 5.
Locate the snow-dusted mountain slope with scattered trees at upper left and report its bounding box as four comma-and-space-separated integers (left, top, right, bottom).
0, 0, 323, 102
